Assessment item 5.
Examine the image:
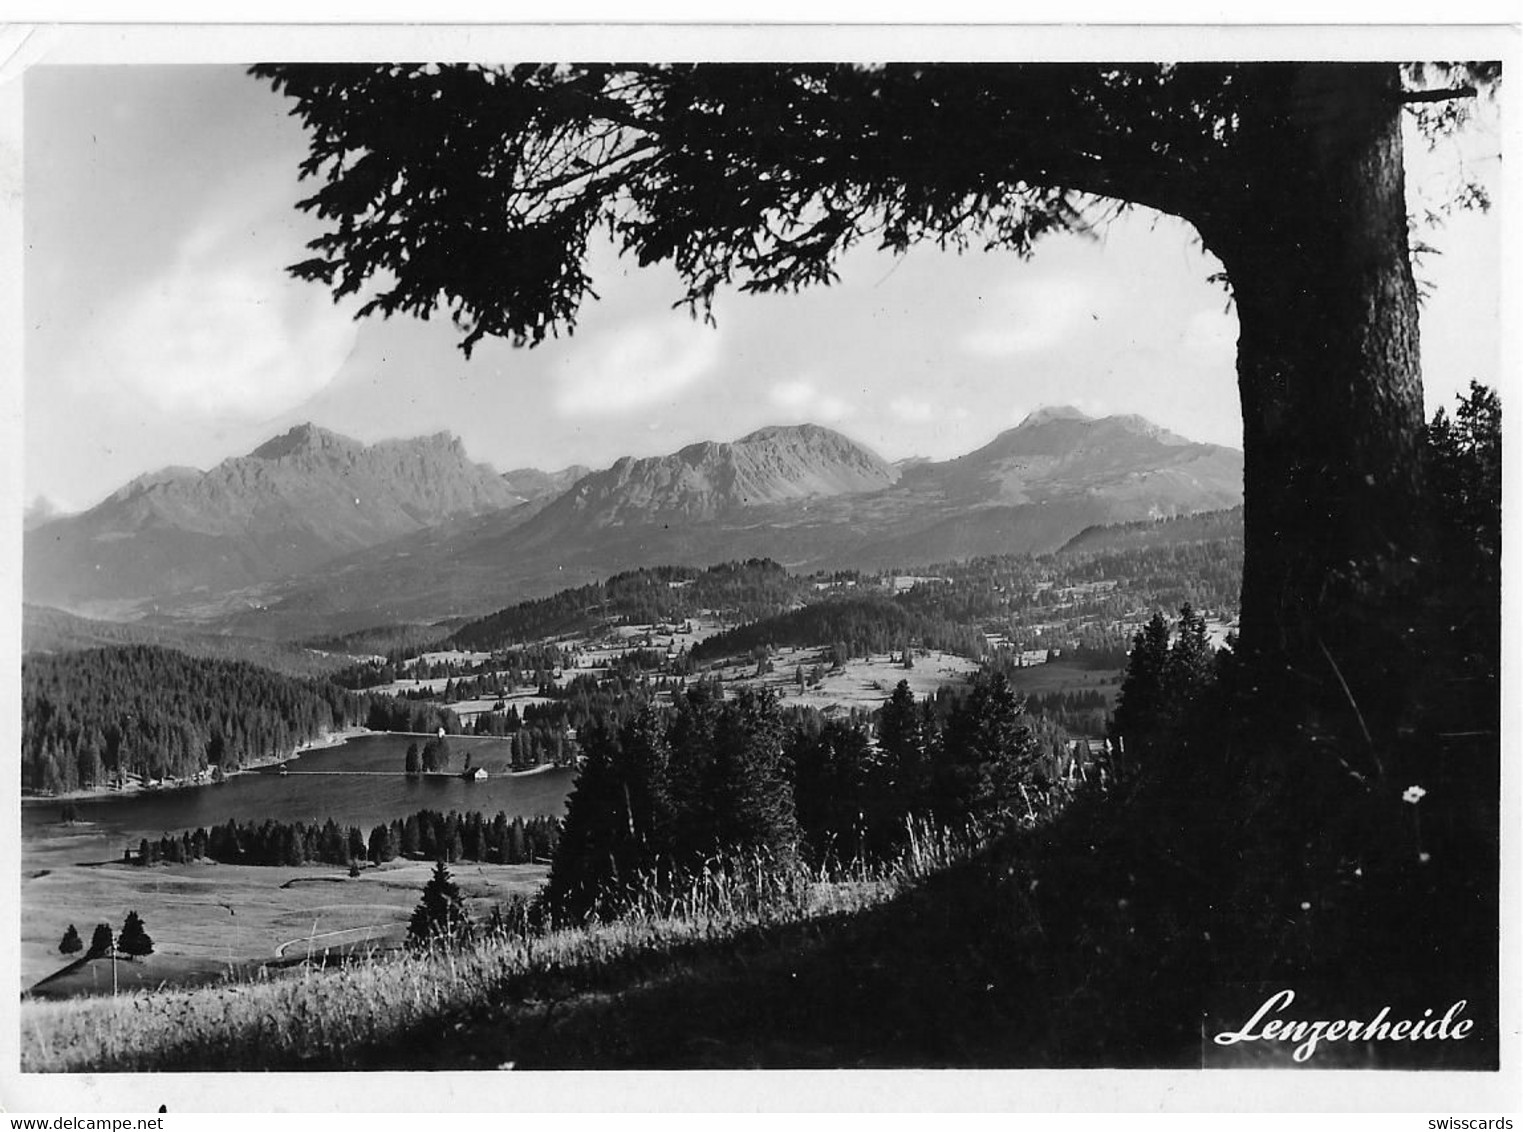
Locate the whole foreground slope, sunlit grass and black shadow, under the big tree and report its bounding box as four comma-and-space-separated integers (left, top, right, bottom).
21, 761, 1497, 1071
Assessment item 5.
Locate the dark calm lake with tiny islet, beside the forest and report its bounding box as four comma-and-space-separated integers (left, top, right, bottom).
21, 734, 576, 859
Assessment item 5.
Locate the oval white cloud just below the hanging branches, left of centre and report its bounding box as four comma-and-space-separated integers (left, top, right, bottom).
556, 317, 720, 416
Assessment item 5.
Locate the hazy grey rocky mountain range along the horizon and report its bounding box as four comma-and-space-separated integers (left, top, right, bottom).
24, 408, 1243, 638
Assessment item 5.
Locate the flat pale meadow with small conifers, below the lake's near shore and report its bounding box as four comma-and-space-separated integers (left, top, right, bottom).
21, 861, 548, 998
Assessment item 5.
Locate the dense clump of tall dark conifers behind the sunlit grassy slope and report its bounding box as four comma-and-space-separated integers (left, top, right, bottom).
544, 670, 1102, 919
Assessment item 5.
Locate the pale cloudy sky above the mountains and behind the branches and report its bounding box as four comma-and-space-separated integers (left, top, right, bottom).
23, 57, 1502, 510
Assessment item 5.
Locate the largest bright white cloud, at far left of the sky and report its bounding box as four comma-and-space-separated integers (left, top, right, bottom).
73, 205, 358, 419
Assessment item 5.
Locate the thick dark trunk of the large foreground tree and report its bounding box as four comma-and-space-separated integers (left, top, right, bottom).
1200, 66, 1424, 725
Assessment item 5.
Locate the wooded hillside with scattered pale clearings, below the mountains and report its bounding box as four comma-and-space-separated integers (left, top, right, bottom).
399, 507, 1243, 682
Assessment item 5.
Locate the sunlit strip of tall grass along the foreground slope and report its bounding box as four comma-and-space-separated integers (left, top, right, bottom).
20, 821, 987, 1073
